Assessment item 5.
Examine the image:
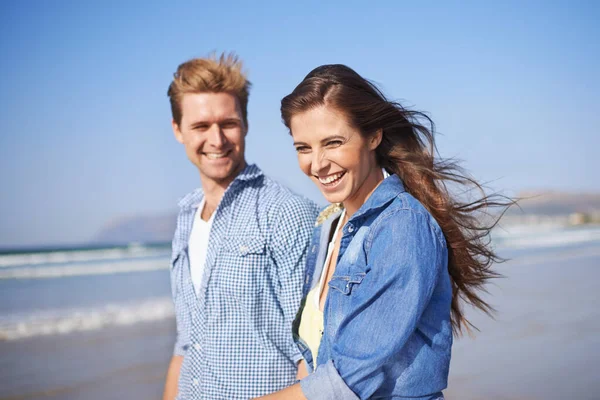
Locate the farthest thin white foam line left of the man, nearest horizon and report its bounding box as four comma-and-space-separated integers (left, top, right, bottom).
0, 246, 168, 268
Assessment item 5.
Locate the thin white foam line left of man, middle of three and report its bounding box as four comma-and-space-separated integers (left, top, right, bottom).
0, 258, 169, 279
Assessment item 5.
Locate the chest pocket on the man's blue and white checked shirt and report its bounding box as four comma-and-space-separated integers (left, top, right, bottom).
216, 236, 269, 300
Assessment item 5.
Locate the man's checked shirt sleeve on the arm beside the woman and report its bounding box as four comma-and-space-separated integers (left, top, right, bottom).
271, 196, 319, 363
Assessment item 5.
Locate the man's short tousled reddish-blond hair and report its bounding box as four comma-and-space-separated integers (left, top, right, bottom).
167, 53, 252, 126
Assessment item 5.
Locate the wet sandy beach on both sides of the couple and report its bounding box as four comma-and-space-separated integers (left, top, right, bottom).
0, 239, 600, 400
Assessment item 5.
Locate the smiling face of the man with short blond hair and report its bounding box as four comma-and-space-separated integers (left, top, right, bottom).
173, 93, 248, 186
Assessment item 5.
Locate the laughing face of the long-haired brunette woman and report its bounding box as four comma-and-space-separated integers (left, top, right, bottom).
290, 106, 382, 211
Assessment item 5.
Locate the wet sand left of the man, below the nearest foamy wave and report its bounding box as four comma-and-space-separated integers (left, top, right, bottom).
0, 319, 175, 400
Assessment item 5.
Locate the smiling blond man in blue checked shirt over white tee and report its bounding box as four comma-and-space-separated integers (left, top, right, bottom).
163, 54, 317, 400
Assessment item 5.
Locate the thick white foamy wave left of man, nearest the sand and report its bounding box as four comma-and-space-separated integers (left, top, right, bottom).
0, 297, 174, 340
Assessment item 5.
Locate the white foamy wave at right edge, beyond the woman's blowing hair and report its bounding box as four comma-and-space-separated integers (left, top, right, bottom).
492, 226, 600, 249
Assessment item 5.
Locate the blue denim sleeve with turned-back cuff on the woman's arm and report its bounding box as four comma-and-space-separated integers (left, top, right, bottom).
301, 208, 447, 400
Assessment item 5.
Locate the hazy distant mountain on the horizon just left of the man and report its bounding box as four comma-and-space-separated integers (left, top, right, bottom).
92, 213, 177, 244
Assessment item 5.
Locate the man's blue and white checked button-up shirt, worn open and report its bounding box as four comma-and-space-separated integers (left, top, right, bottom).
171, 165, 318, 400
